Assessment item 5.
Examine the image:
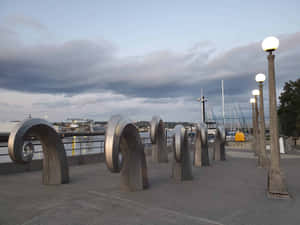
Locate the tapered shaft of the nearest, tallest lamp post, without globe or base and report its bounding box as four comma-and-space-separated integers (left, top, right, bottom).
268, 52, 280, 170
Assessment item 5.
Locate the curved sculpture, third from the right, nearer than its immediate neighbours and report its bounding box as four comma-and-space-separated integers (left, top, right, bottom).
172, 125, 193, 181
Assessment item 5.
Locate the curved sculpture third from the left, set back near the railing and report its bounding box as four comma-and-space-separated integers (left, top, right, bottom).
150, 116, 168, 163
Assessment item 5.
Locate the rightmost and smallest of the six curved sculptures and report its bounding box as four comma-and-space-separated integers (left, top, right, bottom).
214, 126, 226, 161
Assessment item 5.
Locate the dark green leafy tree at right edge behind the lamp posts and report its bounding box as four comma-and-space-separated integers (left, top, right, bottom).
278, 79, 300, 137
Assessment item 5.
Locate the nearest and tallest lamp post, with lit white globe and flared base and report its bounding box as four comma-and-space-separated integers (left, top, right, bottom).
262, 37, 289, 197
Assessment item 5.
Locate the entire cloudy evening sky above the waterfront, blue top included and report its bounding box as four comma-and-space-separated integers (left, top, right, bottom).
0, 0, 300, 121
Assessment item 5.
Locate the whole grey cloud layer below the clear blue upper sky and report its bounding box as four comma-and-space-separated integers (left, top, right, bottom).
0, 17, 300, 121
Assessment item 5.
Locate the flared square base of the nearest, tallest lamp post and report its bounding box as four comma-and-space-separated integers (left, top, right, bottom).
268, 169, 290, 199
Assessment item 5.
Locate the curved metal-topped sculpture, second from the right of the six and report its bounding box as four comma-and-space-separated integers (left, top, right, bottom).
194, 124, 209, 167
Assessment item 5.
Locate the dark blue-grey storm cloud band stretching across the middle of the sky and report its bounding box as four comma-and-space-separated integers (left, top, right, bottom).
0, 28, 300, 101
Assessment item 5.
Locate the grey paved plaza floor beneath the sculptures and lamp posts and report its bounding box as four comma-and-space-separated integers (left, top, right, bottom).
0, 151, 300, 225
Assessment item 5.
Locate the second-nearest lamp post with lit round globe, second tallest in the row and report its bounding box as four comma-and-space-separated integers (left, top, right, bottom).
255, 73, 268, 168
